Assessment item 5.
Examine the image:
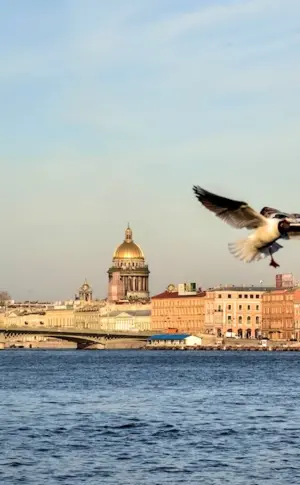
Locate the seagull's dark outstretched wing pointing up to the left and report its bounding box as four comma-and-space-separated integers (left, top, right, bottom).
193, 185, 266, 229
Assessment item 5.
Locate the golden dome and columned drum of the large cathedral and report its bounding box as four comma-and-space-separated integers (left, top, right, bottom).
108, 224, 150, 301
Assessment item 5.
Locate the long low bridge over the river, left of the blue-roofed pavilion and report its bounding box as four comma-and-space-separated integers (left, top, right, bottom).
0, 324, 153, 349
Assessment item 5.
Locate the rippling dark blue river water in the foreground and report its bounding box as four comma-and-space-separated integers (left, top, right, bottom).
0, 350, 300, 485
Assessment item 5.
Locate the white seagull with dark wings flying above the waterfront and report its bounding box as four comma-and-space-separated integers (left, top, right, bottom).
193, 185, 300, 268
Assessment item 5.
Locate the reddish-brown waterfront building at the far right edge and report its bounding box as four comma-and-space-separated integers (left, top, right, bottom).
262, 287, 300, 340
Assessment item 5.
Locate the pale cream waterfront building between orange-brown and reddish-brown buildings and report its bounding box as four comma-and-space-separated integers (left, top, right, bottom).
204, 285, 274, 338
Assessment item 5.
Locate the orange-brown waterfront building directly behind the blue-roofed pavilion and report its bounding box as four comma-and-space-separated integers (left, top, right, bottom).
151, 284, 205, 334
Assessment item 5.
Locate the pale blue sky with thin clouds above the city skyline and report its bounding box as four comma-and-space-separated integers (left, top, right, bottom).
0, 0, 300, 299
